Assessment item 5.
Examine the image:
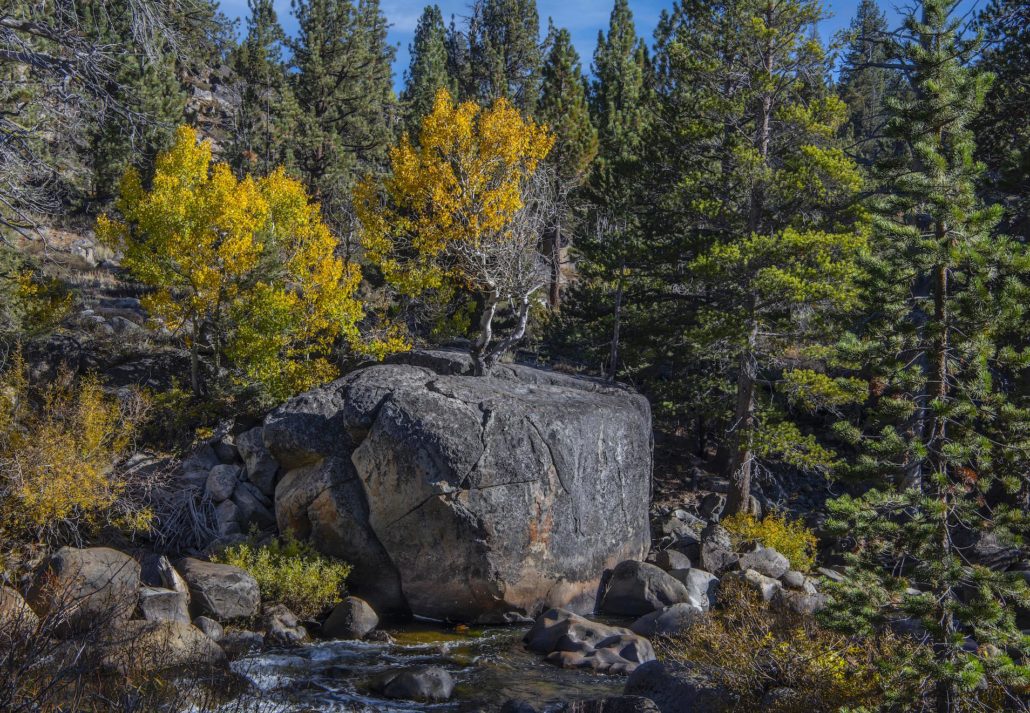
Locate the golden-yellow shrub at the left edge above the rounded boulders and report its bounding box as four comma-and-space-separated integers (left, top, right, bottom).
0, 352, 149, 544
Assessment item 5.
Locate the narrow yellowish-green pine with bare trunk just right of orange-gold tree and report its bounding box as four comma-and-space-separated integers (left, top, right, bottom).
537, 20, 597, 308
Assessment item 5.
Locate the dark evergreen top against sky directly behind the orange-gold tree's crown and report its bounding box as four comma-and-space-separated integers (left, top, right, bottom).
467, 0, 542, 114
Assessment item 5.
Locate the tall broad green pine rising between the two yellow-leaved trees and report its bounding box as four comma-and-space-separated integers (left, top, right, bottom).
289, 0, 396, 228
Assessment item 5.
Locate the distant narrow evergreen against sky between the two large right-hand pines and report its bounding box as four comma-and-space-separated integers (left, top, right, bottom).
838, 0, 896, 166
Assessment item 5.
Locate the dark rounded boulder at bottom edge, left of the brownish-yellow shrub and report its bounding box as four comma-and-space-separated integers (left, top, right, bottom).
623, 661, 737, 713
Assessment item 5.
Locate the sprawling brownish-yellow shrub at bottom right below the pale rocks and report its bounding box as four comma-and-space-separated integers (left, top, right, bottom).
659, 583, 900, 713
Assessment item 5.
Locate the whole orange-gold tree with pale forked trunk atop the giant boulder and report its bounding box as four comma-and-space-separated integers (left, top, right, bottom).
355, 90, 554, 375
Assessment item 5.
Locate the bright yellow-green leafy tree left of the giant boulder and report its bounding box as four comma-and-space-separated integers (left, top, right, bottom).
97, 127, 385, 398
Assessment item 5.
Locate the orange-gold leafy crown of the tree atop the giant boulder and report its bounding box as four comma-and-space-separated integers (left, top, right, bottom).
355, 90, 554, 296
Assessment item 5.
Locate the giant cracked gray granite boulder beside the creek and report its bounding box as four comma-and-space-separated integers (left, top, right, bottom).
263, 351, 651, 623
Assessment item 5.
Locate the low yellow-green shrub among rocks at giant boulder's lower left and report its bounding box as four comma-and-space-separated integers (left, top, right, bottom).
214, 534, 350, 618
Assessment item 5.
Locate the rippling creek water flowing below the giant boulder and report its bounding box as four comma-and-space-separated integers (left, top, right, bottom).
233, 626, 625, 713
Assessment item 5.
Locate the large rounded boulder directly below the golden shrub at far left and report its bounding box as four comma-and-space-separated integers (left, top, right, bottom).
29, 547, 140, 632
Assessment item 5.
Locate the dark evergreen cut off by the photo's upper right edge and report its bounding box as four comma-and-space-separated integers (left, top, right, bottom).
974, 0, 1030, 240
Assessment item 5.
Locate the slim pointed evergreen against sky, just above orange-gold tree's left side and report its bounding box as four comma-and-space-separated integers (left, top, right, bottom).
401, 5, 457, 131
